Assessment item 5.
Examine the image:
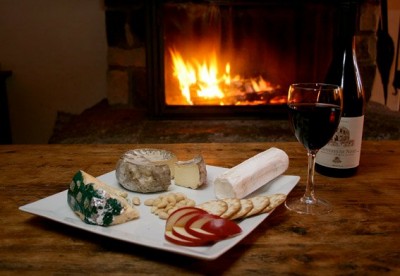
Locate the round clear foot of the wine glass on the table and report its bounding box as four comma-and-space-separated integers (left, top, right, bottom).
285, 198, 332, 215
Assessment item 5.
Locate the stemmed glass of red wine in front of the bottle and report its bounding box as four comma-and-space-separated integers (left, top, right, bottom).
285, 83, 343, 215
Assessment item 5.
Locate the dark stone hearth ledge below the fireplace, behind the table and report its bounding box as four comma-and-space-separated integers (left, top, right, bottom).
49, 100, 400, 144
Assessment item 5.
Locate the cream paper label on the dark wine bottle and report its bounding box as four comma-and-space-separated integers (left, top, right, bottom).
316, 116, 364, 169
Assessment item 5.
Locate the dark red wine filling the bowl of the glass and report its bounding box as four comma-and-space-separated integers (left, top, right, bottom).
288, 103, 340, 150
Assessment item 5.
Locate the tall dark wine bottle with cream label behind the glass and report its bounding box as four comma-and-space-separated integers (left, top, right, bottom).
315, 0, 365, 177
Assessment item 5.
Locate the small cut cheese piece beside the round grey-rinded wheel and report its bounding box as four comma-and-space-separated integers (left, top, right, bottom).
175, 155, 207, 189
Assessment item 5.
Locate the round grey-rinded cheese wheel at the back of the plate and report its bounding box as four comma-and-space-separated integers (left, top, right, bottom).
115, 149, 177, 193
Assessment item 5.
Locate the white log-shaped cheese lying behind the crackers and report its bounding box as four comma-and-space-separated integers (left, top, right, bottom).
214, 147, 289, 199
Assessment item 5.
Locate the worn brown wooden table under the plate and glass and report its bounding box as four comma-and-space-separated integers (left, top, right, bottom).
0, 141, 400, 275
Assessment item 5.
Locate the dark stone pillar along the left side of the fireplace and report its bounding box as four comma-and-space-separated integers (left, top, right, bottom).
105, 0, 147, 107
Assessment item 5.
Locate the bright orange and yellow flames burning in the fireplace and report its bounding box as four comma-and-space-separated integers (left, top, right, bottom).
169, 49, 279, 105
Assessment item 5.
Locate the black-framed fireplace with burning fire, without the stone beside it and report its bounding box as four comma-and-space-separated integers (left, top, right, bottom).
149, 1, 335, 116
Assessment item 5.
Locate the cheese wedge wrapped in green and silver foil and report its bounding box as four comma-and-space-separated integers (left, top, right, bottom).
67, 170, 139, 226
